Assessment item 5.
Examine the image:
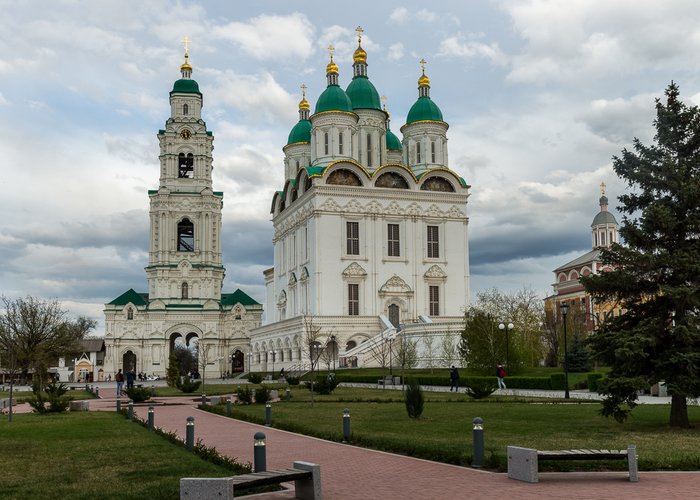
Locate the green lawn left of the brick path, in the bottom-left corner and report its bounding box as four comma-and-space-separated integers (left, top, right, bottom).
0, 412, 239, 499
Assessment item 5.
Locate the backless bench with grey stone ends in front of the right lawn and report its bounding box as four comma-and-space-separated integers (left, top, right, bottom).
508, 444, 639, 483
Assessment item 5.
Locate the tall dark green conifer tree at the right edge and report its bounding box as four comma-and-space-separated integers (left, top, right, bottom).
582, 82, 700, 427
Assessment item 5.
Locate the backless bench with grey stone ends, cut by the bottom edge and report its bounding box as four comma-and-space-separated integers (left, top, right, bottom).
180, 461, 323, 500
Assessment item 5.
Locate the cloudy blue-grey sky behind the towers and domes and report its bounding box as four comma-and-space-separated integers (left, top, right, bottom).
0, 0, 700, 333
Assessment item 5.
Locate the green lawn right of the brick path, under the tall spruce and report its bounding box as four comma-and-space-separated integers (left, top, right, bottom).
208, 388, 700, 470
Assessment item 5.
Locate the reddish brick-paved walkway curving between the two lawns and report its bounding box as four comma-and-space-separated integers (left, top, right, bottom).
82, 389, 700, 500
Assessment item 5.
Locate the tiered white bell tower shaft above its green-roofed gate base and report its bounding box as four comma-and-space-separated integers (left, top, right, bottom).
146, 37, 225, 308
